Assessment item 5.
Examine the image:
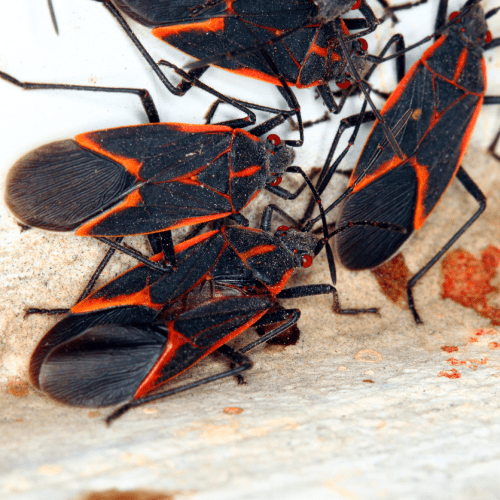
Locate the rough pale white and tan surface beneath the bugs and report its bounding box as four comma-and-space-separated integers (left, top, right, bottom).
0, 1, 500, 500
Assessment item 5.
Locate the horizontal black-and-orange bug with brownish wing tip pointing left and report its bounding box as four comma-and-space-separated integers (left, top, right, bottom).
5, 123, 300, 266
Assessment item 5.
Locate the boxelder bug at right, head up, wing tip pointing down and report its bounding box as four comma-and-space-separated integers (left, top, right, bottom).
310, 0, 500, 323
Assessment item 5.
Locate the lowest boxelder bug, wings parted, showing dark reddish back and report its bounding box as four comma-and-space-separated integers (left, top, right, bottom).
30, 152, 404, 423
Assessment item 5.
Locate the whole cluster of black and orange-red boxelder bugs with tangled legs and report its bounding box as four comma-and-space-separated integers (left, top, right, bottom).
0, 0, 500, 423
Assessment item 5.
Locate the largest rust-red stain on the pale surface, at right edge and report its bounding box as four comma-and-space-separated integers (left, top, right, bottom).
442, 245, 500, 324
